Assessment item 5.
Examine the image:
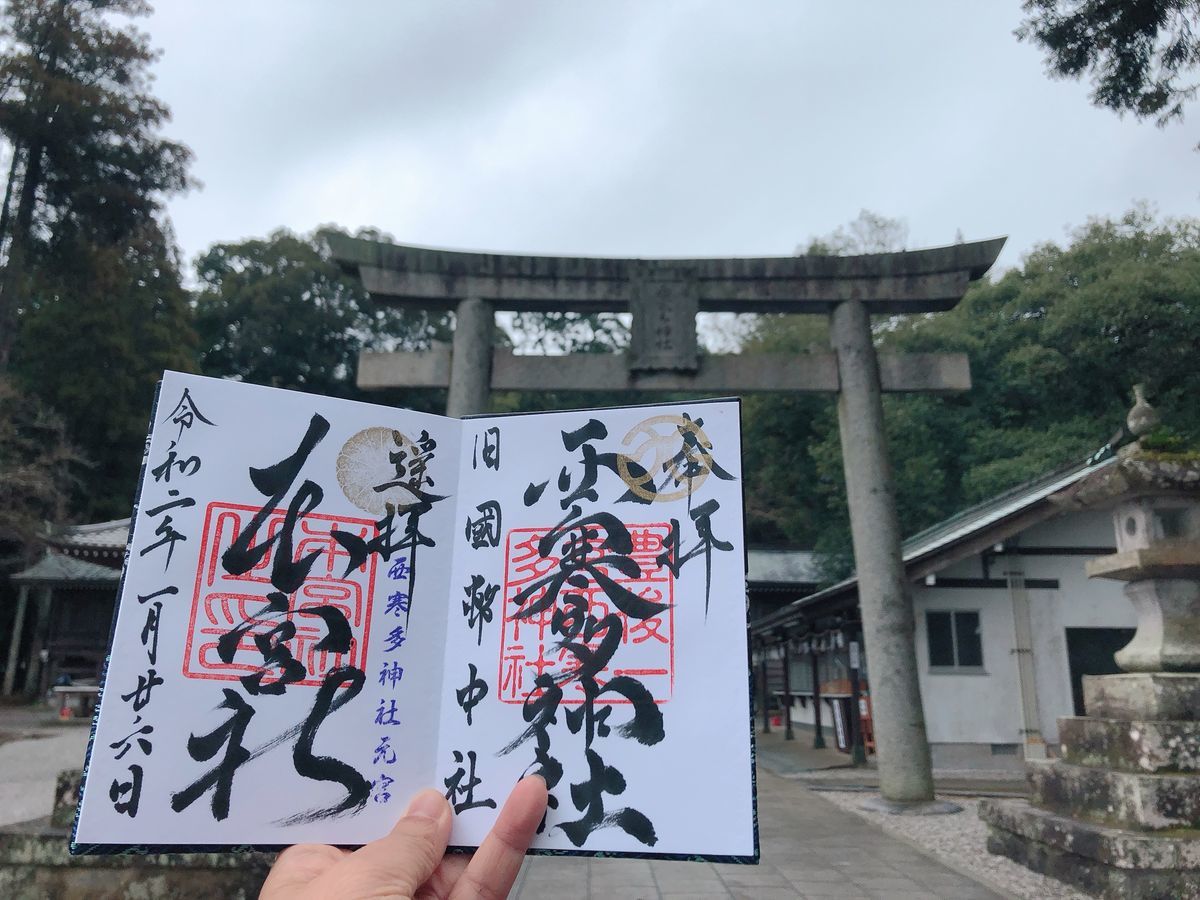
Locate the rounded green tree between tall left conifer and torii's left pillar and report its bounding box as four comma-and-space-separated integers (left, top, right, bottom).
196, 230, 450, 406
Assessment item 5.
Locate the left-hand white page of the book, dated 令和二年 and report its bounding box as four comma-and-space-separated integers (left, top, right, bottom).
74, 373, 460, 847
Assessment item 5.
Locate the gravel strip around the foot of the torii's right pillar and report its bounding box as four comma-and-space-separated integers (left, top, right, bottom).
815, 791, 1093, 900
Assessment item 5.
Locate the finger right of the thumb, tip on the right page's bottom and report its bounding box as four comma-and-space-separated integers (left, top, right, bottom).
450, 775, 546, 900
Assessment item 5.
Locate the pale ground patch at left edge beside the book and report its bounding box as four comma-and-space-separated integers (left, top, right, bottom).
0, 726, 88, 824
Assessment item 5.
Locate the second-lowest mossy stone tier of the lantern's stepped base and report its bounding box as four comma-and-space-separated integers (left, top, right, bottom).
1026, 760, 1200, 832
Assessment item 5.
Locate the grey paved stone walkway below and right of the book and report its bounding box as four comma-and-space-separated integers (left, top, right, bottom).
511, 768, 1003, 900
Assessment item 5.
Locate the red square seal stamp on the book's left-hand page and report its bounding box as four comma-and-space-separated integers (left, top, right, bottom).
184, 502, 378, 688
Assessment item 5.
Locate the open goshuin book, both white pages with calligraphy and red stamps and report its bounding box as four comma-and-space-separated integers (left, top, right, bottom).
72, 372, 758, 862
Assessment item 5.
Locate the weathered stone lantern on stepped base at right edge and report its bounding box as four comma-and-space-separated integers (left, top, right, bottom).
979, 390, 1200, 900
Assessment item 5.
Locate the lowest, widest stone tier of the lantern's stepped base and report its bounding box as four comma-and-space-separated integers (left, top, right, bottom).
979, 799, 1200, 900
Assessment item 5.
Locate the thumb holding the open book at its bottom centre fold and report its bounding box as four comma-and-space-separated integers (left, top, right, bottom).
313, 790, 451, 896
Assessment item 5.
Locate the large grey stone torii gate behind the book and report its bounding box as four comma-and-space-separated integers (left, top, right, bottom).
328, 234, 1004, 804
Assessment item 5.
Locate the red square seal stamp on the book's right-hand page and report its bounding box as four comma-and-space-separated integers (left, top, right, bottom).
498, 522, 674, 706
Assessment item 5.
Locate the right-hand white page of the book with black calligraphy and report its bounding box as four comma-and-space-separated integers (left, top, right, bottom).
438, 401, 756, 858
